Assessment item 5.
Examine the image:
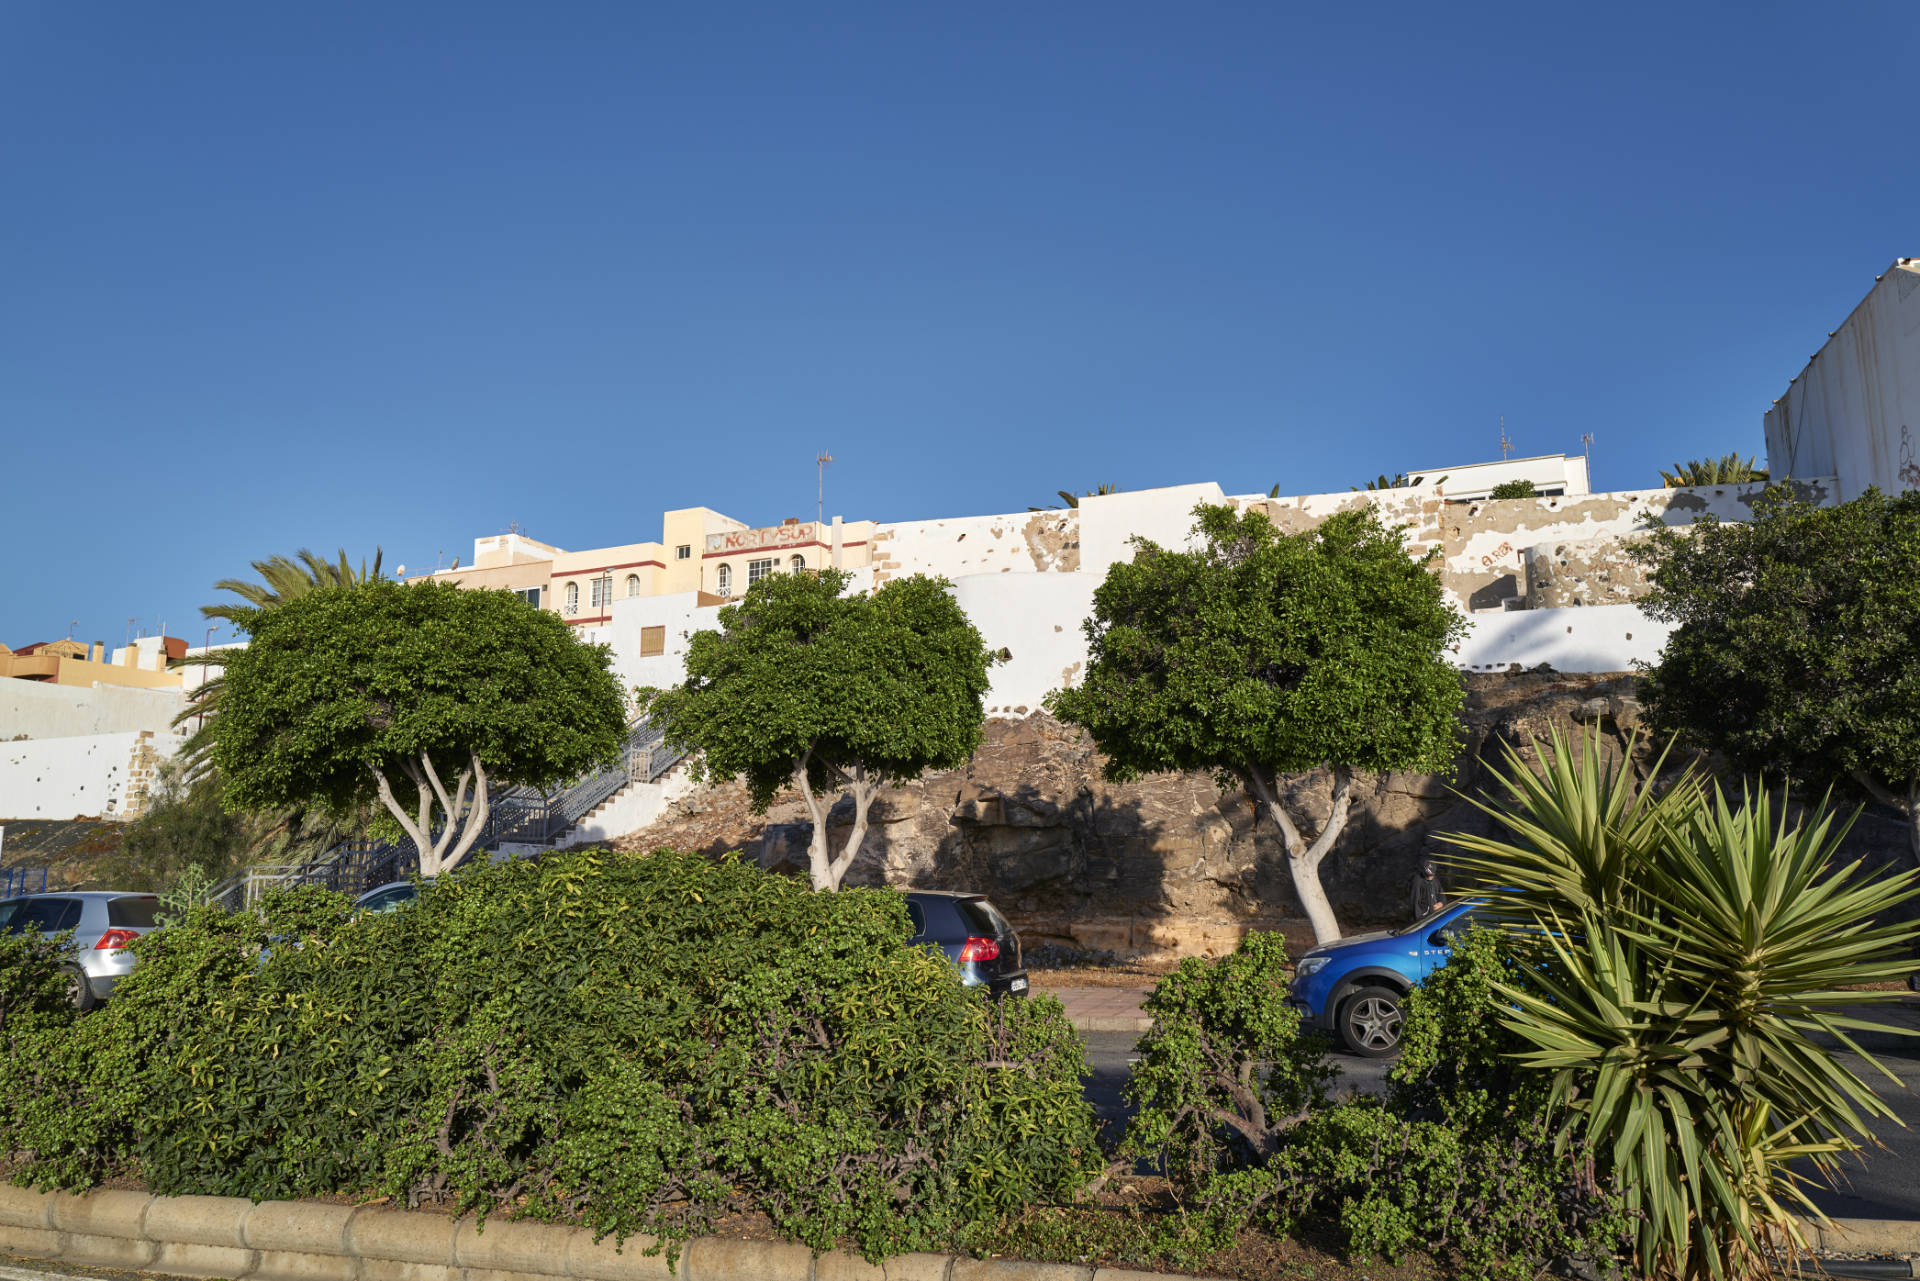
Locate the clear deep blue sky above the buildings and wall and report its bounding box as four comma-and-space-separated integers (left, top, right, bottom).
0, 0, 1920, 645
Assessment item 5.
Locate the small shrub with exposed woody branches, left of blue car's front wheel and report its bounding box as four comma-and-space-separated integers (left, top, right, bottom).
1121, 930, 1336, 1196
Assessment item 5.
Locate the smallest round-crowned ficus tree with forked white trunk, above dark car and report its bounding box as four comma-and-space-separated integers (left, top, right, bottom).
639, 570, 993, 889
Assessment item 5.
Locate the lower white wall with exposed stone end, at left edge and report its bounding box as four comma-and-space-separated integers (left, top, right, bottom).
0, 730, 177, 818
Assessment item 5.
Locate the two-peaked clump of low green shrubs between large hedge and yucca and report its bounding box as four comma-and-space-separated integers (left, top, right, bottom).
1121, 931, 1626, 1275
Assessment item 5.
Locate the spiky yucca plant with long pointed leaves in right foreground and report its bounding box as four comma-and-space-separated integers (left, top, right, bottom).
1446, 732, 1920, 1279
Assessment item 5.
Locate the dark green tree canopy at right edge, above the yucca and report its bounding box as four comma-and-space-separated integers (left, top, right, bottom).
1638, 486, 1920, 858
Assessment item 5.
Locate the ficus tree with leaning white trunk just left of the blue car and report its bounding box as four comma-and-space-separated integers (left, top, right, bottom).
1048, 503, 1465, 943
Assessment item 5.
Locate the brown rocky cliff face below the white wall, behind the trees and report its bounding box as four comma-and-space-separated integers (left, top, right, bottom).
620, 672, 1901, 955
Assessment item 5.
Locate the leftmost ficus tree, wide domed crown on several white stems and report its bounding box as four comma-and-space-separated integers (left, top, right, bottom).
213, 580, 626, 876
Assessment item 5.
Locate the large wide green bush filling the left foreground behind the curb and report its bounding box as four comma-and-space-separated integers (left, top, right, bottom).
7, 851, 1102, 1256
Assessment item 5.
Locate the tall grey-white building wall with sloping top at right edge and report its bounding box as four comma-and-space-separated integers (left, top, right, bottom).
1763, 257, 1920, 501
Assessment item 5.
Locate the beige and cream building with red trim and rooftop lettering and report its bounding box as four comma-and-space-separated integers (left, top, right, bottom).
407, 507, 876, 626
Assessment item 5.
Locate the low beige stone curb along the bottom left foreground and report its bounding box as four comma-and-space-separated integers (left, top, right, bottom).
0, 1185, 1221, 1281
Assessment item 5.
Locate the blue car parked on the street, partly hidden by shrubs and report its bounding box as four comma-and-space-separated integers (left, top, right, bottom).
1288, 901, 1494, 1058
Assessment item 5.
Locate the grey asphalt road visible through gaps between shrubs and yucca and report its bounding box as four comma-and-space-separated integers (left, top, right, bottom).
1081, 1001, 1920, 1220
